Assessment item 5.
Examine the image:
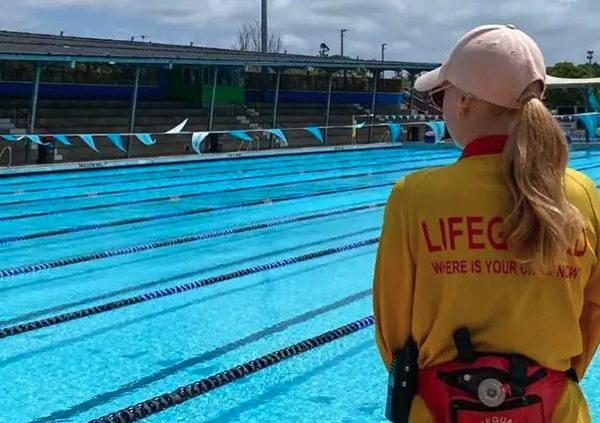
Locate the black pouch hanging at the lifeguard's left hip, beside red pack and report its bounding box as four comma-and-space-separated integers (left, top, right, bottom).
385, 339, 419, 423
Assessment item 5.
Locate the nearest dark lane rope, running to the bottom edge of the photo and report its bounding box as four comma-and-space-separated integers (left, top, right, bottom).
89, 316, 375, 423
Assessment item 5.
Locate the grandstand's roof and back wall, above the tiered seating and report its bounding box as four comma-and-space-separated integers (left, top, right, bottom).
0, 31, 438, 104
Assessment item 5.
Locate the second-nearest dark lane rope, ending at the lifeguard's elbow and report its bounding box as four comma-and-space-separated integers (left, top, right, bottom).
0, 237, 379, 339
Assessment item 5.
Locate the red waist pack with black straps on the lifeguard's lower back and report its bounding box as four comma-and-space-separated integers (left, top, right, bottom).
416, 332, 569, 423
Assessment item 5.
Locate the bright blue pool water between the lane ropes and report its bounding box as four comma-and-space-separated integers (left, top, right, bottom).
0, 146, 600, 423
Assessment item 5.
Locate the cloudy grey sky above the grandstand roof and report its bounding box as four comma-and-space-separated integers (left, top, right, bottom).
0, 0, 600, 65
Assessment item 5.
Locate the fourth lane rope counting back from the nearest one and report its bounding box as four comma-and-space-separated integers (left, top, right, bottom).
0, 182, 394, 245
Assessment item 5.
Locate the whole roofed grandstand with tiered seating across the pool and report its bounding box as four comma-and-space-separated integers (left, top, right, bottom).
0, 31, 439, 164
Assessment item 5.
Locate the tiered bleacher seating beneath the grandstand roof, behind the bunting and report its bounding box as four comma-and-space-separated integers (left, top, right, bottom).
0, 99, 426, 164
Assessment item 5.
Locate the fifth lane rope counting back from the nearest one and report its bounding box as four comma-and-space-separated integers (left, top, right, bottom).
0, 161, 435, 222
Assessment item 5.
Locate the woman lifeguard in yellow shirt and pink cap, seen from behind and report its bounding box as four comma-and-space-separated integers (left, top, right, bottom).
373, 25, 600, 423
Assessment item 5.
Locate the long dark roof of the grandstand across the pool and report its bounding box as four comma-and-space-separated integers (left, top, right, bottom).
0, 31, 440, 71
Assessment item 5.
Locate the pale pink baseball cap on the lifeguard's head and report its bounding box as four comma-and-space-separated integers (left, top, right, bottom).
415, 25, 546, 108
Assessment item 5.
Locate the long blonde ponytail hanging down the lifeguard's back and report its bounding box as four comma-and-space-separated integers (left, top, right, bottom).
503, 84, 584, 274
